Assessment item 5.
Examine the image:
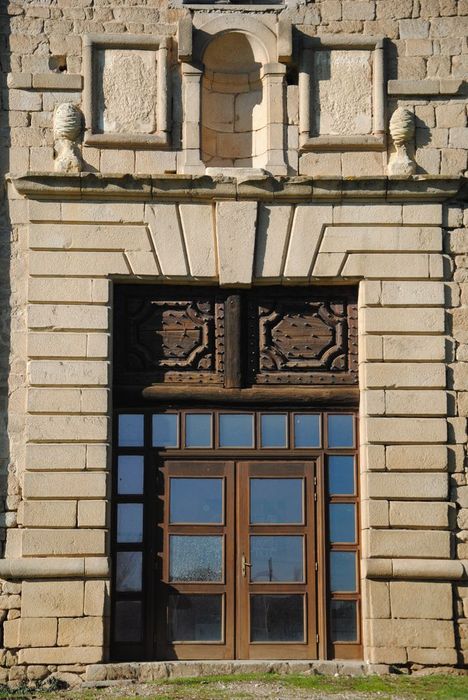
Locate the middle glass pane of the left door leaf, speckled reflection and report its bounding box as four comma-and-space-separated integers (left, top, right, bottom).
169, 535, 223, 582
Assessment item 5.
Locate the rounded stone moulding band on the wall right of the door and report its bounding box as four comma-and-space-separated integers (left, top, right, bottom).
362, 559, 468, 581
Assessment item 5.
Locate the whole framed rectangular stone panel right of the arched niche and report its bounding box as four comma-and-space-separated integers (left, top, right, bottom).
299, 36, 386, 150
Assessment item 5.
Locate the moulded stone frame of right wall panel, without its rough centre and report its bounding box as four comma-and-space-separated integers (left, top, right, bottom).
299, 34, 387, 151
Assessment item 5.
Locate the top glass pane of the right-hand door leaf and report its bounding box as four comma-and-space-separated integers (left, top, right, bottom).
250, 479, 304, 525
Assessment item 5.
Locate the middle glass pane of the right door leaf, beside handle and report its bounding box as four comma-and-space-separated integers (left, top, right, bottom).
250, 535, 304, 583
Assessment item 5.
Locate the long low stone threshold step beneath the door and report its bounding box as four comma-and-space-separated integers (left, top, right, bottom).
83, 660, 390, 688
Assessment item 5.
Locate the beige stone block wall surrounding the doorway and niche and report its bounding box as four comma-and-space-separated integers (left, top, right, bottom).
0, 0, 468, 683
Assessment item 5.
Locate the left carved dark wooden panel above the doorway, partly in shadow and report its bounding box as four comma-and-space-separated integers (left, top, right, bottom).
115, 287, 224, 385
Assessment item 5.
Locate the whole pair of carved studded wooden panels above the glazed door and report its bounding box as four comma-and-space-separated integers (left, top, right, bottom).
114, 285, 357, 397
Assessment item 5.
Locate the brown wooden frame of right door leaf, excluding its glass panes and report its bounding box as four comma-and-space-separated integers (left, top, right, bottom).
236, 459, 317, 659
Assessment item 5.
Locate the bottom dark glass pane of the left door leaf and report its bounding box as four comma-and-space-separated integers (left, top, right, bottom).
168, 594, 223, 642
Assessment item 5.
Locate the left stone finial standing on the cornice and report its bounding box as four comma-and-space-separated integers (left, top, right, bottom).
54, 102, 82, 173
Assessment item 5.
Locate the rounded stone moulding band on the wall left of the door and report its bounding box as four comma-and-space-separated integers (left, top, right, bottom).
0, 557, 110, 581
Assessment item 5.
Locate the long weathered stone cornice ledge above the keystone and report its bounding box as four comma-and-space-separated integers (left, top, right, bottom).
7, 172, 468, 202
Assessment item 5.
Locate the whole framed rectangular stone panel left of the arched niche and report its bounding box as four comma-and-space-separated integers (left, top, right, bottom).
84, 34, 170, 148
